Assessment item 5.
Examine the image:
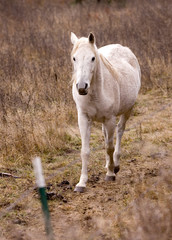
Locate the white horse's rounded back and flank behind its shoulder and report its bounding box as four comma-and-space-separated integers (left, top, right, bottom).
98, 44, 141, 114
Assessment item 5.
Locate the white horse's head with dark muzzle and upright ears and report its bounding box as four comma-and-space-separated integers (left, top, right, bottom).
71, 33, 97, 95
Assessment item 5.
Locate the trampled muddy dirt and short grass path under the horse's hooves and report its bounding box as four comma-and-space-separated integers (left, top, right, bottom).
0, 91, 172, 240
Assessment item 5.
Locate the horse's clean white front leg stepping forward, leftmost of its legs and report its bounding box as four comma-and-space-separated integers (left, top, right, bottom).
74, 112, 91, 192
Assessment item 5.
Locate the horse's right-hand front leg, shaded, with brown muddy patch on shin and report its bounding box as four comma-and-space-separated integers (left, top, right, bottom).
103, 117, 116, 181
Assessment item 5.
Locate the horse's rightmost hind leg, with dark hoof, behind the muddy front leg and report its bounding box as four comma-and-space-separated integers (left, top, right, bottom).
114, 110, 131, 173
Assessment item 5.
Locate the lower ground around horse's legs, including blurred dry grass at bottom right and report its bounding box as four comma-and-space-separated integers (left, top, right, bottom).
1, 91, 172, 240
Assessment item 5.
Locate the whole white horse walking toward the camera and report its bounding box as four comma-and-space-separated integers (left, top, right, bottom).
71, 33, 141, 192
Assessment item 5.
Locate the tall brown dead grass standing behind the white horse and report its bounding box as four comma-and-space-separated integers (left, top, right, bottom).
0, 0, 172, 162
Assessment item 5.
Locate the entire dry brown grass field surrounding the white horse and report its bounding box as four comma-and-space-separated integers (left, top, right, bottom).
0, 0, 172, 240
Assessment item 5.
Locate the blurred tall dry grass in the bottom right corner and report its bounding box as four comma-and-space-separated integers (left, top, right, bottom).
120, 163, 172, 240
